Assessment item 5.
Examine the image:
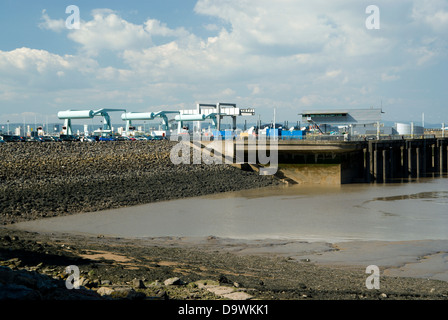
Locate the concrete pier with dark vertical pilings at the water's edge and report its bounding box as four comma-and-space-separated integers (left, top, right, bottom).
236, 138, 448, 184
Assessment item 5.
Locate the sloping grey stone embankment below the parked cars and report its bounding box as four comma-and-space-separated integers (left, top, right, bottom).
0, 140, 280, 225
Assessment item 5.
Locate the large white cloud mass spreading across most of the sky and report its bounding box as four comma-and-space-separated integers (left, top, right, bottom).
0, 0, 448, 122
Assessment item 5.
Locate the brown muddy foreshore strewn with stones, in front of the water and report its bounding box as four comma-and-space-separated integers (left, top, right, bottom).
0, 227, 448, 300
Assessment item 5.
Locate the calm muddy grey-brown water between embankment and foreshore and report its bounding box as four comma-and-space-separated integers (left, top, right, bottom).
15, 178, 448, 243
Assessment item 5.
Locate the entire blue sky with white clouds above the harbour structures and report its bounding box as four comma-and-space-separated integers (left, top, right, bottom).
0, 0, 448, 127
